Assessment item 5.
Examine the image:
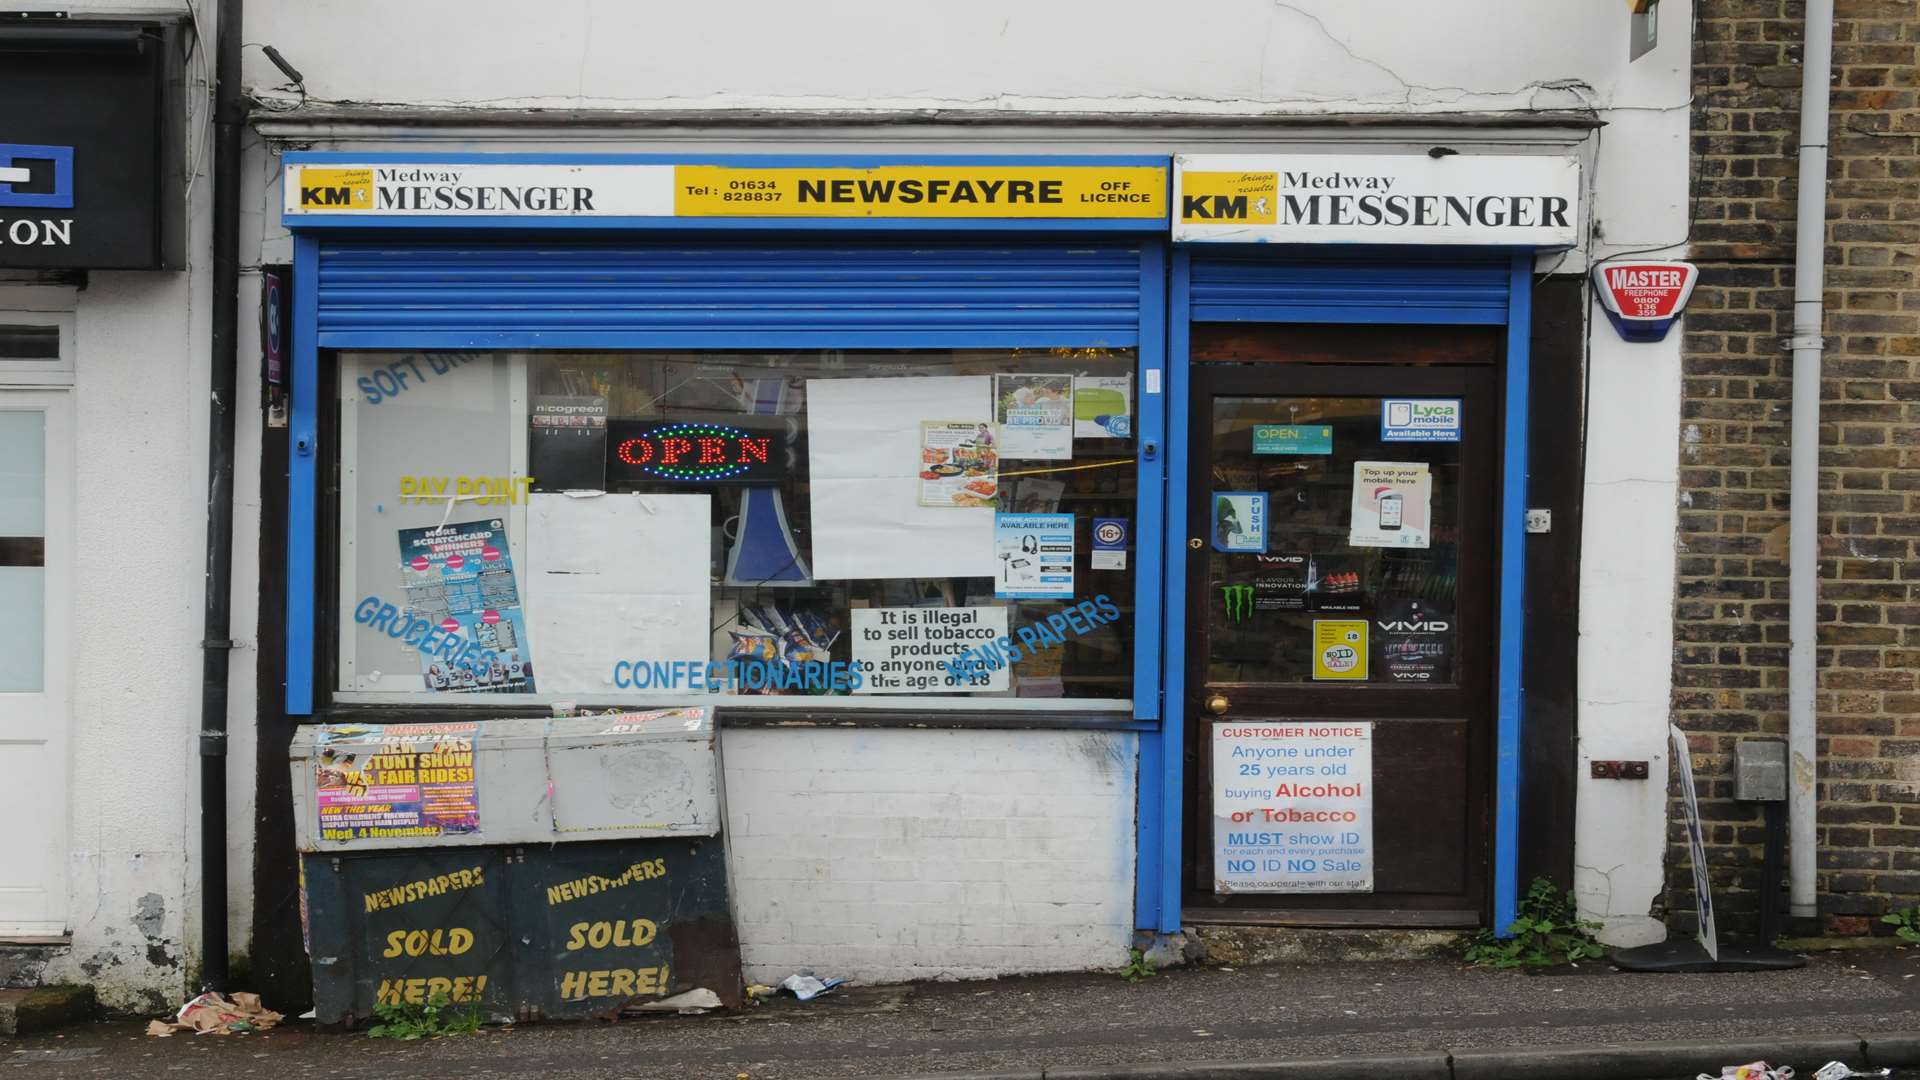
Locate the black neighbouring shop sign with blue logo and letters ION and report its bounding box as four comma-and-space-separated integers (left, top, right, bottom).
0, 19, 186, 269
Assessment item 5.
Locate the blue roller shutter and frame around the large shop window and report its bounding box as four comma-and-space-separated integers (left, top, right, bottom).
286, 154, 1167, 728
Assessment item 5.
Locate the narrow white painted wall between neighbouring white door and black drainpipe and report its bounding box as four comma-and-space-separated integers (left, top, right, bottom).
34, 259, 207, 1009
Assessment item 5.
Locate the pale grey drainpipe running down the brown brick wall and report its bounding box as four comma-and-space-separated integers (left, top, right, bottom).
1788, 0, 1834, 919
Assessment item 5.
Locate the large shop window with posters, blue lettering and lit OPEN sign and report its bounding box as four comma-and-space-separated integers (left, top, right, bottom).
336, 348, 1137, 709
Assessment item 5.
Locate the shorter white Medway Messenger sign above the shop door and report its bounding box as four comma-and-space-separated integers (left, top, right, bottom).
1173, 154, 1580, 248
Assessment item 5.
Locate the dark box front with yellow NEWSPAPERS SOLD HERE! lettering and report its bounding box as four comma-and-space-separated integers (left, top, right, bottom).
301, 838, 743, 1024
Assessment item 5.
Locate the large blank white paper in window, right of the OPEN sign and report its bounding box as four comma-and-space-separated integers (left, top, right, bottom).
806, 375, 995, 580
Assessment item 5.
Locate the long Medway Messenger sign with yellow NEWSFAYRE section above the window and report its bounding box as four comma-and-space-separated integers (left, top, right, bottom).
284, 161, 1167, 221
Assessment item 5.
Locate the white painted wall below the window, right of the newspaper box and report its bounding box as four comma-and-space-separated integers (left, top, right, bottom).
722, 728, 1137, 984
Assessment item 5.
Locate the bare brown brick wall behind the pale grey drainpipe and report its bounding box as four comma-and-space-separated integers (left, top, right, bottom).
1668, 0, 1920, 934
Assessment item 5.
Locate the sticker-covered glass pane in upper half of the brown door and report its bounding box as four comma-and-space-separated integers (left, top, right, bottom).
1206, 396, 1461, 686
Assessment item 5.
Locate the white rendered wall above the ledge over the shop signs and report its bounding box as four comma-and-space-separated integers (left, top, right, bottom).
248, 0, 1688, 113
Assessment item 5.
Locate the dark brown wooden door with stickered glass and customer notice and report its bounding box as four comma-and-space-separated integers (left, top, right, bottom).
1185, 327, 1501, 926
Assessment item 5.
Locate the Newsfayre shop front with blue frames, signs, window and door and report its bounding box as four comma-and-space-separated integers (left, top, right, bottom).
270, 152, 1582, 978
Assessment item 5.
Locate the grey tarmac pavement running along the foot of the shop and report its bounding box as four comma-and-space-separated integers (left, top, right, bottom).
0, 949, 1920, 1080
